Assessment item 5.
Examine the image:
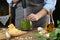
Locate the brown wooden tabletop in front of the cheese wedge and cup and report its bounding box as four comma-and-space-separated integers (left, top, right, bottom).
0, 29, 39, 40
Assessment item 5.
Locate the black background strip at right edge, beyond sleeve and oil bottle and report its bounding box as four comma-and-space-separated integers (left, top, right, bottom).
53, 0, 60, 27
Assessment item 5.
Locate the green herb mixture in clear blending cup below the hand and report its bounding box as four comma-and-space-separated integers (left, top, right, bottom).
20, 20, 32, 30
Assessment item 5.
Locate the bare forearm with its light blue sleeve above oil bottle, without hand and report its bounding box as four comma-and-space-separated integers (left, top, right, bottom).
36, 0, 56, 18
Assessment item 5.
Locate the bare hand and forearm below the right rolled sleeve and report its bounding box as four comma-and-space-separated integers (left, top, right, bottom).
27, 9, 47, 21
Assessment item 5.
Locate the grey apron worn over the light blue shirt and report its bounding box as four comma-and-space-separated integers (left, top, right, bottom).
15, 0, 47, 28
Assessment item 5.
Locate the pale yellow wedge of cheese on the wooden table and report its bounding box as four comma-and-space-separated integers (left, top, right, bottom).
8, 24, 27, 36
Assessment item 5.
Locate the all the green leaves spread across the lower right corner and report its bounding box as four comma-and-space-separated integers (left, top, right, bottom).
35, 20, 60, 40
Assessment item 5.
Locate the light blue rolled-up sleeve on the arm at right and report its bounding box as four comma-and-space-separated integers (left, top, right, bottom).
43, 0, 56, 12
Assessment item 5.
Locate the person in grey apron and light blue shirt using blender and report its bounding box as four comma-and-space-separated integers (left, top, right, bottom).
7, 0, 56, 28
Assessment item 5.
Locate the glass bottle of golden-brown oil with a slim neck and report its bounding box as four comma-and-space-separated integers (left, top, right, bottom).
45, 13, 55, 33
